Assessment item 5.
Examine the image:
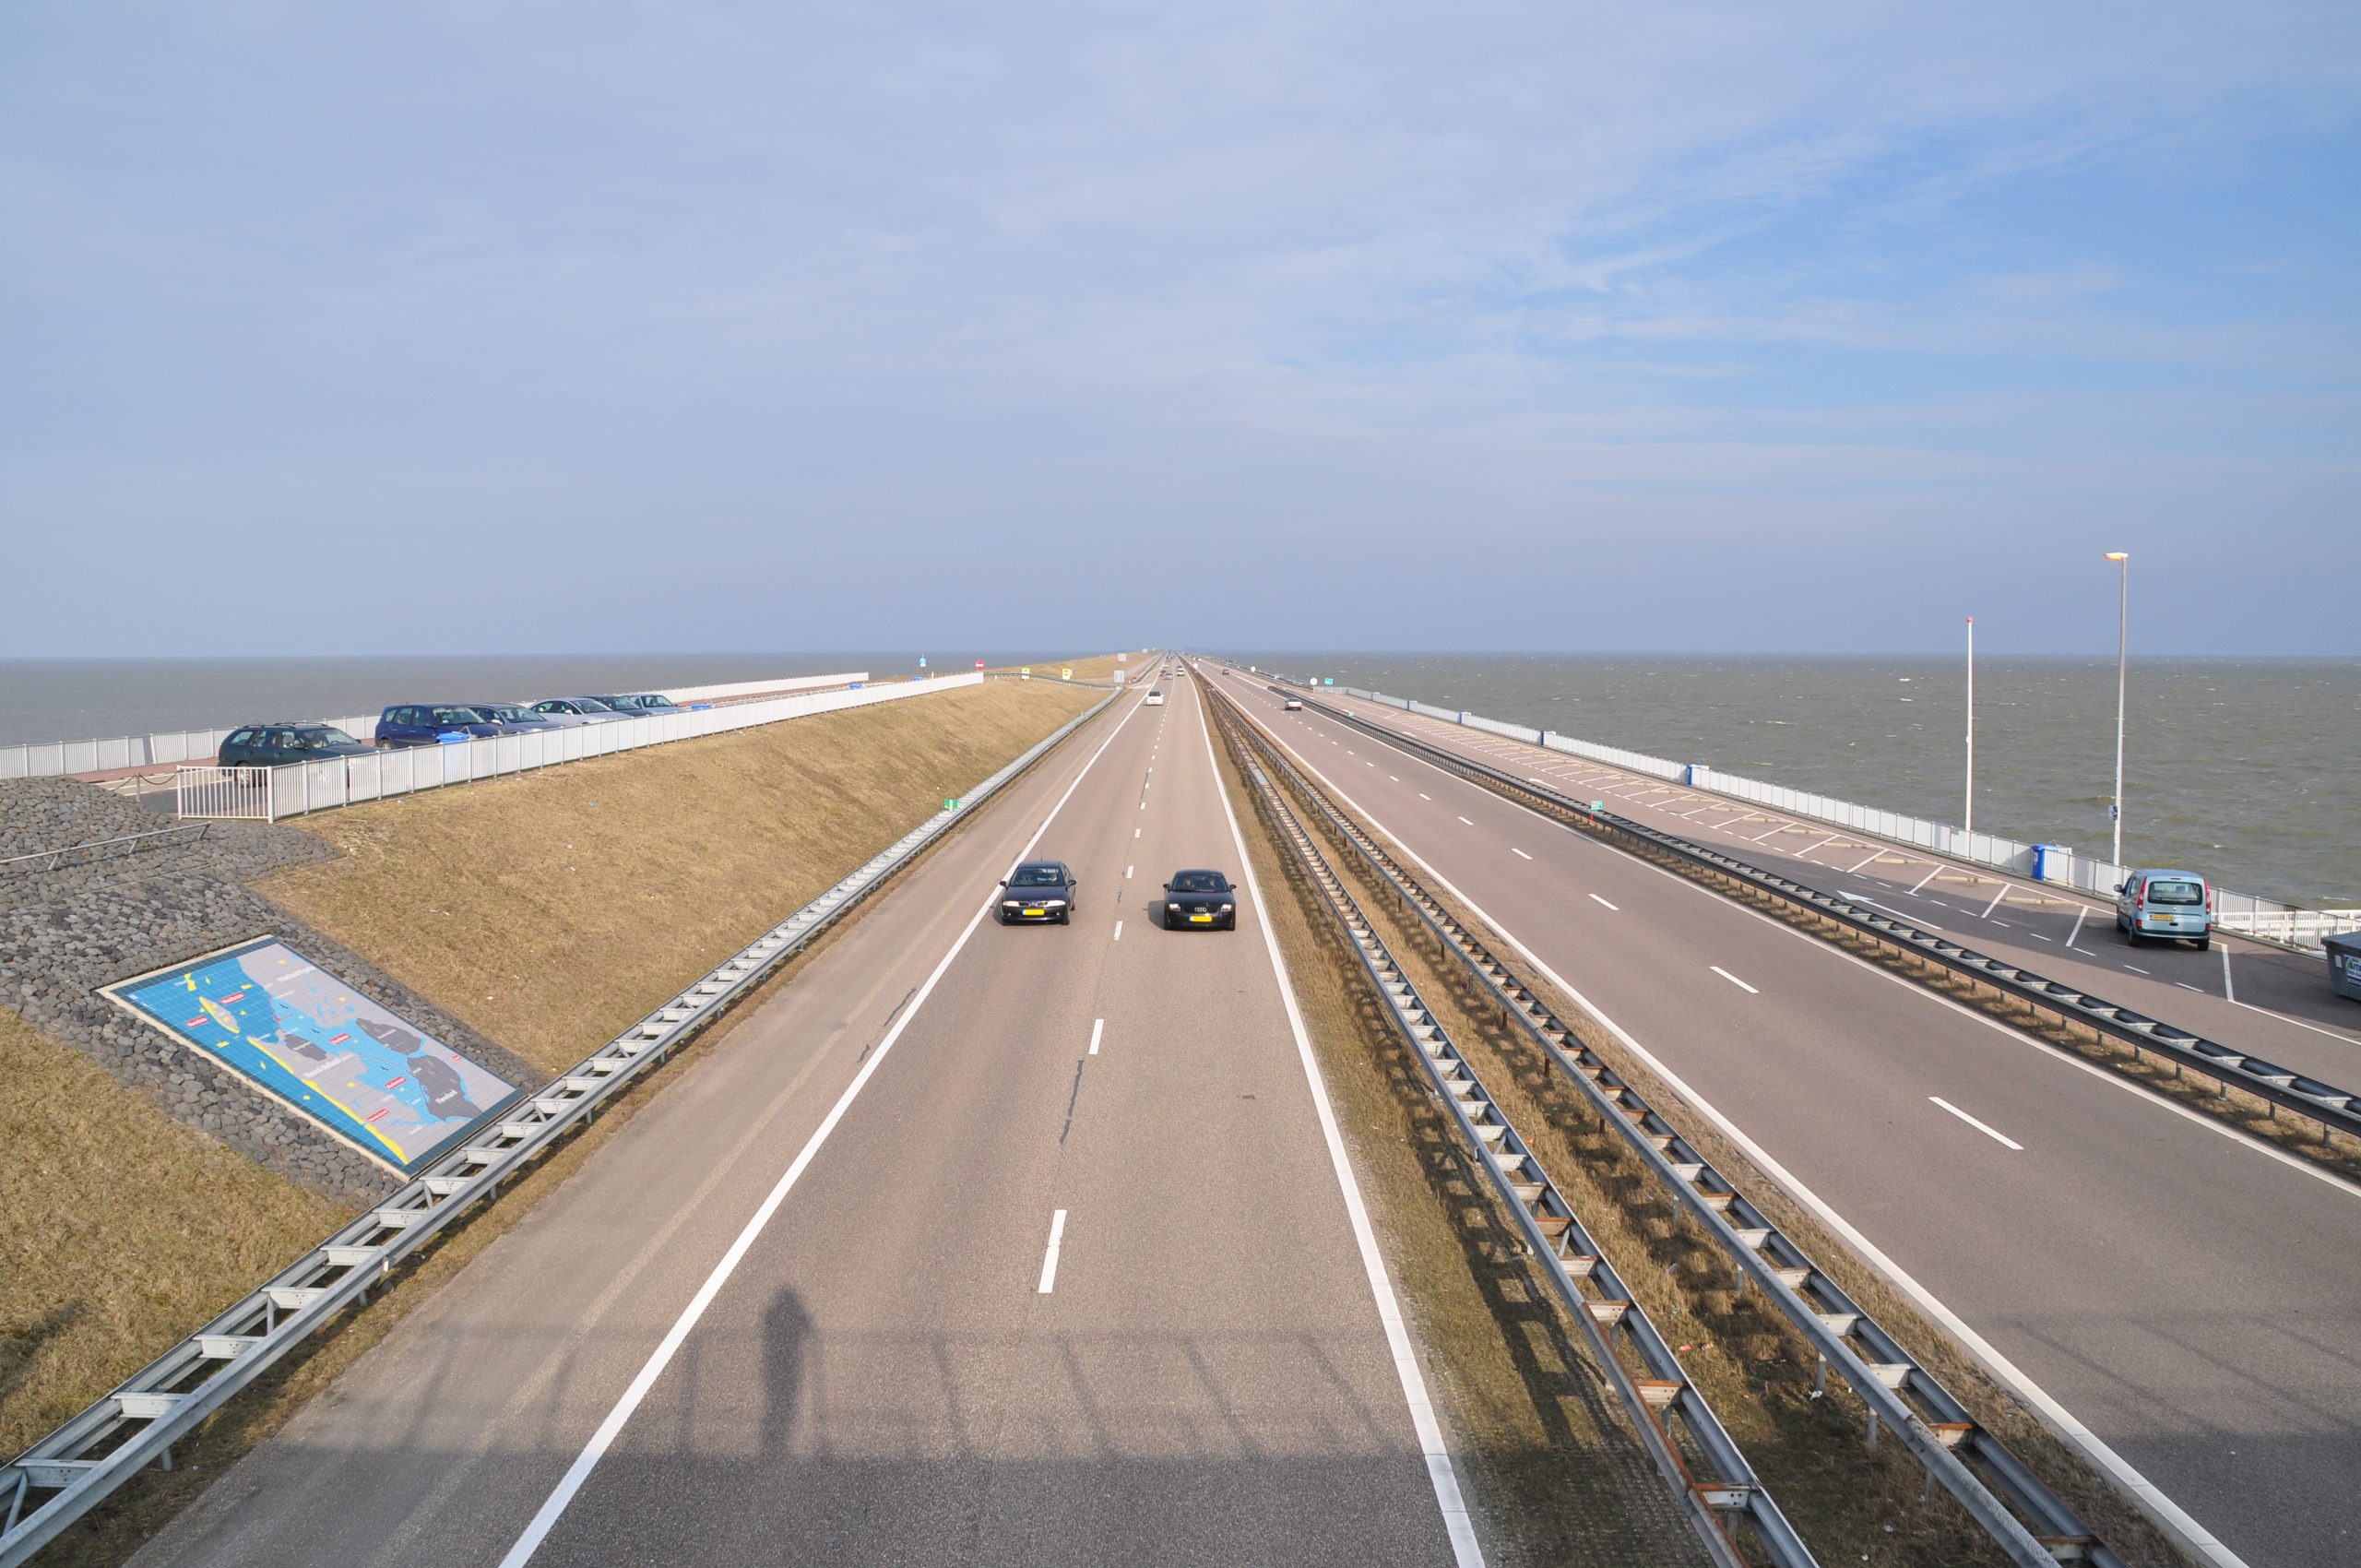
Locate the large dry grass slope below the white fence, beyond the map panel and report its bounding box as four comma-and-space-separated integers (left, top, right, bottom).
262, 680, 1105, 1072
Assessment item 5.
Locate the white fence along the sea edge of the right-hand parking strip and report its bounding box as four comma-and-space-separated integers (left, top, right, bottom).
1336, 687, 2361, 949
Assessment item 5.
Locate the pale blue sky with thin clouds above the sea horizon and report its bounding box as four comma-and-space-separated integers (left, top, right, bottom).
0, 0, 2361, 657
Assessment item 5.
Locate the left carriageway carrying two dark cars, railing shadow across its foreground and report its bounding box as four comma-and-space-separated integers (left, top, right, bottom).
135, 687, 1480, 1568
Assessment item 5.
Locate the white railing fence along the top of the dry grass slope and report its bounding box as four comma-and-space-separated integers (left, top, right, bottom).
174, 673, 982, 822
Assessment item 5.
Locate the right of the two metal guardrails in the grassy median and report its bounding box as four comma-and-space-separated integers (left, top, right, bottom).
1226, 699, 2122, 1568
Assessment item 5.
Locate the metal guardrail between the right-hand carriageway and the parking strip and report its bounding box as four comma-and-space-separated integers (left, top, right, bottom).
1282, 692, 2361, 1141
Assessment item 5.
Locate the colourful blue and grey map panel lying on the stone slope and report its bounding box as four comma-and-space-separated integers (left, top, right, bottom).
106, 937, 517, 1173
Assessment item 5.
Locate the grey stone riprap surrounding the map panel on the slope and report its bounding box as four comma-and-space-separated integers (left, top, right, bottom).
0, 779, 543, 1205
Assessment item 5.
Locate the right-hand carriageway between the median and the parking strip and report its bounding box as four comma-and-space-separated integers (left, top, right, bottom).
1204, 666, 2361, 1568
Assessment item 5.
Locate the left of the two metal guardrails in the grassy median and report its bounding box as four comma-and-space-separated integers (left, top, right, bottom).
1240, 713, 1816, 1568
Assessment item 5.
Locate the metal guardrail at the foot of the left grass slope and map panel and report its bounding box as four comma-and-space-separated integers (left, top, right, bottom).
0, 695, 1114, 1568
